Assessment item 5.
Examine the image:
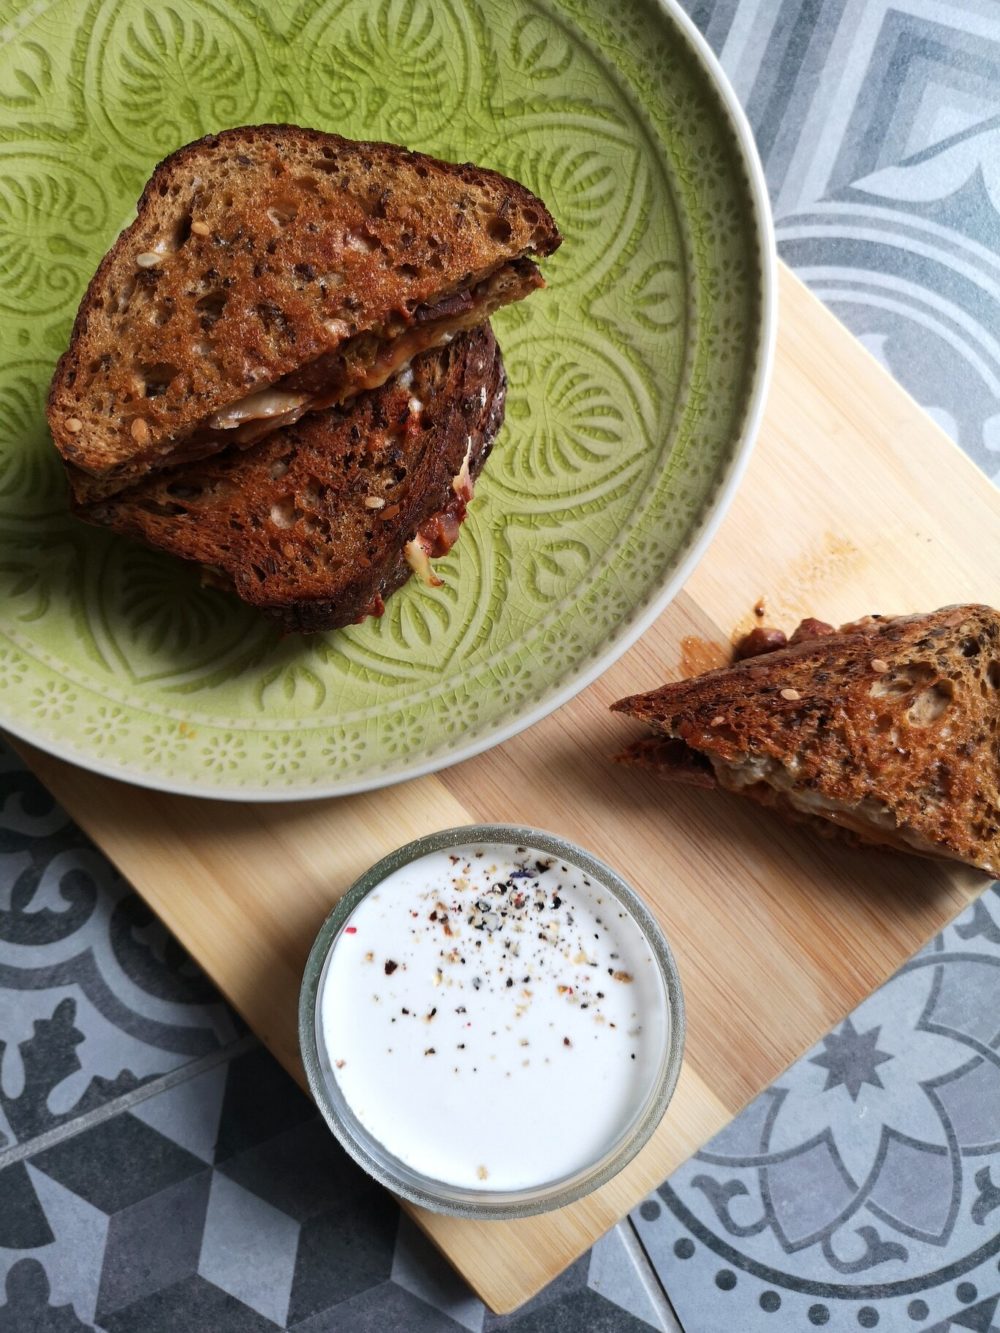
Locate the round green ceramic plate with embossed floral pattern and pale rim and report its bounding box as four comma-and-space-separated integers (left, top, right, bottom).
0, 0, 773, 800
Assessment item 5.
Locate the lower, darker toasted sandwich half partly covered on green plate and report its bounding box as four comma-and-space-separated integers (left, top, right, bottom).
77, 325, 505, 632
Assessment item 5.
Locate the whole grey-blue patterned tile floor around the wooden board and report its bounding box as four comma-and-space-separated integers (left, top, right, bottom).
0, 0, 1000, 1333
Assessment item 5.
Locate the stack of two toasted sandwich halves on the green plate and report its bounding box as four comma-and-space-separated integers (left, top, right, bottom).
48, 125, 560, 631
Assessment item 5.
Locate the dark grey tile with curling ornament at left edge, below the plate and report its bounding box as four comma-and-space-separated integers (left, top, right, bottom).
0, 748, 244, 1152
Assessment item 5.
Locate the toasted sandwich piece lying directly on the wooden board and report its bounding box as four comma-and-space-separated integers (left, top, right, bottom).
612, 605, 1000, 874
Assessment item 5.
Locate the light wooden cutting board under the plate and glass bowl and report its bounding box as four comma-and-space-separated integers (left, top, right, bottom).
17, 262, 1000, 1310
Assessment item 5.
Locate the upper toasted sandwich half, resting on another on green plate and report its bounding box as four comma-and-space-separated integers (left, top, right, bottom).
48, 125, 560, 500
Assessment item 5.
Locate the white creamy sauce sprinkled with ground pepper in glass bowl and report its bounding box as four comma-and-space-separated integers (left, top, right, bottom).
319, 845, 669, 1190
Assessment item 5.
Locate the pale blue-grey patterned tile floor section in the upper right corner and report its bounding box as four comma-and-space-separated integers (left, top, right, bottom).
688, 0, 1000, 477
